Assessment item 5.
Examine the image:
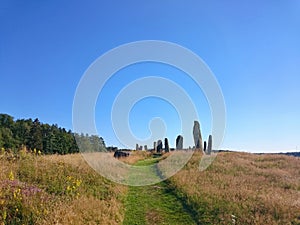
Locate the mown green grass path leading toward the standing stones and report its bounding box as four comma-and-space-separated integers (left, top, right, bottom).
123, 158, 197, 225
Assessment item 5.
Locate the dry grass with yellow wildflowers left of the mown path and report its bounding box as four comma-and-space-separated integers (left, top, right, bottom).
0, 149, 126, 224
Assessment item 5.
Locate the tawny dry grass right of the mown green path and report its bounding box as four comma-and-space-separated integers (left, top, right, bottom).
171, 152, 300, 224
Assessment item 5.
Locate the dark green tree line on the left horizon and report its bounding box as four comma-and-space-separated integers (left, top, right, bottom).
0, 114, 106, 154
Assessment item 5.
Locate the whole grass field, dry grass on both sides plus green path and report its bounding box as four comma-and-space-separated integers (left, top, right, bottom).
0, 150, 300, 224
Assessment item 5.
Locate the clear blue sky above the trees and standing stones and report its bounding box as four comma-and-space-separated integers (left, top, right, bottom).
0, 0, 300, 152
